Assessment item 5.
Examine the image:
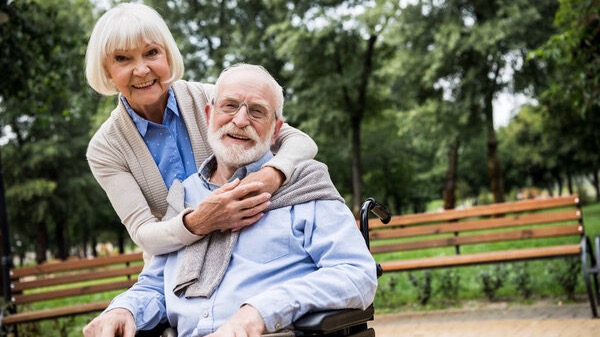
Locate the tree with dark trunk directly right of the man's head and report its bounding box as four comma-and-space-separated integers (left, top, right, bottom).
269, 1, 399, 212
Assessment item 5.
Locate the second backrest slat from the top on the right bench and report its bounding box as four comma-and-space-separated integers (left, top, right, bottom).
369, 210, 581, 240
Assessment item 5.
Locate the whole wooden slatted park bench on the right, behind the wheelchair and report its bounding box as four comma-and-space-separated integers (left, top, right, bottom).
369, 195, 600, 317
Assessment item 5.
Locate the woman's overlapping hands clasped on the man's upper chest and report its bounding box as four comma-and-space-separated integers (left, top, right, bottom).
183, 167, 284, 235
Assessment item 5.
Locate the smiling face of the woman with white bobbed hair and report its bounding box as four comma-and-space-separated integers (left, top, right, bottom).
106, 43, 171, 118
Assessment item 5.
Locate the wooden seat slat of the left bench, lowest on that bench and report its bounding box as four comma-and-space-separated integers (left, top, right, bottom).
2, 301, 110, 325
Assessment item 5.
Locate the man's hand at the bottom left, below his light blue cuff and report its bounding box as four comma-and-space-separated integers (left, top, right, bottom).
83, 308, 136, 337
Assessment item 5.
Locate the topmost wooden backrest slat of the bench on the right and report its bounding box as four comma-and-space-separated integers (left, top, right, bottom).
369, 195, 579, 229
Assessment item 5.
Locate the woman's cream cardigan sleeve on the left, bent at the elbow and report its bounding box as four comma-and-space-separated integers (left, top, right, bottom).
87, 129, 202, 255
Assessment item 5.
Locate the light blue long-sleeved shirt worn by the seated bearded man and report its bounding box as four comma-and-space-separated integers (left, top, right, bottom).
107, 153, 377, 337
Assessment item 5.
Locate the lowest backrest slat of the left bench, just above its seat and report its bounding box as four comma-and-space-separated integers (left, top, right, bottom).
12, 277, 137, 304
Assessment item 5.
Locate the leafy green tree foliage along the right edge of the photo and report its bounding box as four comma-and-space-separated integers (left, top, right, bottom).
530, 0, 600, 201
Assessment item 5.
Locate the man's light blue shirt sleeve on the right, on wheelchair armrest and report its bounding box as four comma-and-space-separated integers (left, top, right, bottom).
246, 200, 377, 331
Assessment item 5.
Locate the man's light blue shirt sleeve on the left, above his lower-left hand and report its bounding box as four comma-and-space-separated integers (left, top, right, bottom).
105, 255, 167, 330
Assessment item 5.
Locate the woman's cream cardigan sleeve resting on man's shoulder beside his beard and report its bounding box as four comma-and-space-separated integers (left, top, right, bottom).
263, 123, 318, 184
